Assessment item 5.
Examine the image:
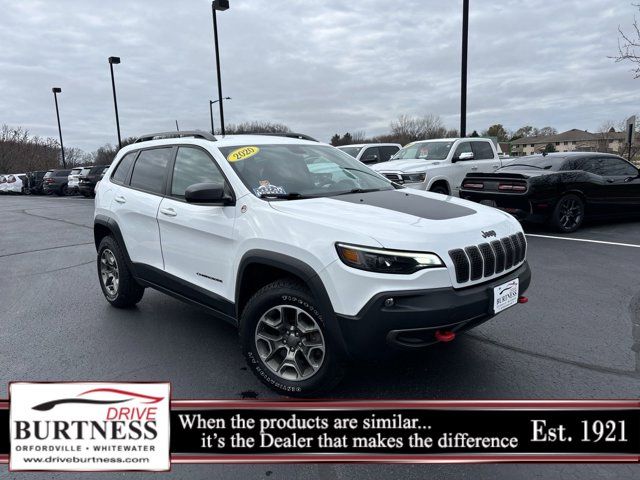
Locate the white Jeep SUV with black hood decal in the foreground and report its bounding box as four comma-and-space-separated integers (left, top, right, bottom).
94, 131, 531, 396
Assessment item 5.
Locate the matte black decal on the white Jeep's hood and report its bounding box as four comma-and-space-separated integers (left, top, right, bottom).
331, 189, 476, 220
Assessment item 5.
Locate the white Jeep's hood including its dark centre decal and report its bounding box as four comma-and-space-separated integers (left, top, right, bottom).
270, 188, 521, 256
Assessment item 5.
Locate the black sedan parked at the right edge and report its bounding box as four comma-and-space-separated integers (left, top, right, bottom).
460, 152, 640, 232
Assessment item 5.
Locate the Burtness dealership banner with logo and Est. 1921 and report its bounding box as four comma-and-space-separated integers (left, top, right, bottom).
0, 382, 640, 471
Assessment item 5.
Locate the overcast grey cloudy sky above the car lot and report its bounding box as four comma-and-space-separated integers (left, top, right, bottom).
0, 0, 640, 151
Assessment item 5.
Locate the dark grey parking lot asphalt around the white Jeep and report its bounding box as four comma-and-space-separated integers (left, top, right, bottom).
0, 196, 640, 480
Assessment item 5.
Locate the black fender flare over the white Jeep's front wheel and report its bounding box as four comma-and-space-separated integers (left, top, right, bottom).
235, 249, 347, 353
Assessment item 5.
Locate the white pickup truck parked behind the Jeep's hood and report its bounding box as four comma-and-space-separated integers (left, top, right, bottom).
370, 138, 502, 196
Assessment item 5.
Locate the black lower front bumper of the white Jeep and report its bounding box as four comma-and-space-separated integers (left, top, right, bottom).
337, 261, 531, 357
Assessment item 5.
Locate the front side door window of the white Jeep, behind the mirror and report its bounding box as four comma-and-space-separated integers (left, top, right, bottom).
171, 147, 225, 197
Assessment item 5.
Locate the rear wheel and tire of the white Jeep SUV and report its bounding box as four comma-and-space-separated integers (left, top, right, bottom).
97, 236, 144, 308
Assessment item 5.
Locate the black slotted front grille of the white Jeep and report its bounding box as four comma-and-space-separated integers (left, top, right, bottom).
449, 233, 527, 283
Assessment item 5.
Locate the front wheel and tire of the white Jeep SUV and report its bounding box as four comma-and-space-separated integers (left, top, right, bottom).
240, 279, 344, 397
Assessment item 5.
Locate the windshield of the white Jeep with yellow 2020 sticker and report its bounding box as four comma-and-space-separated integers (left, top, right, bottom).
220, 144, 394, 198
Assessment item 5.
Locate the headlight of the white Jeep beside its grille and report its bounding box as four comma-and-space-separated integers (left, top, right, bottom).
336, 243, 444, 274
